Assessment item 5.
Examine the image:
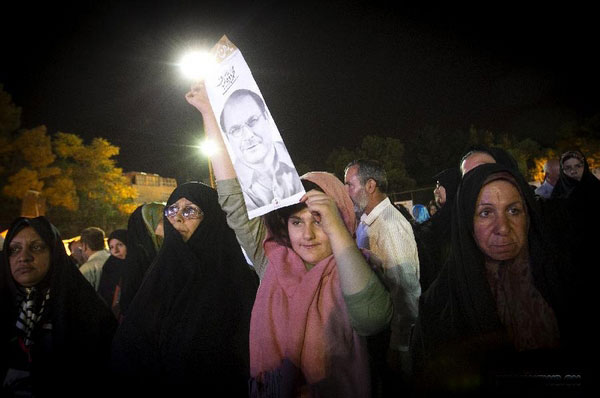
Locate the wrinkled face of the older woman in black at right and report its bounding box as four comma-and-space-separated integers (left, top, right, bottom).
473, 180, 528, 261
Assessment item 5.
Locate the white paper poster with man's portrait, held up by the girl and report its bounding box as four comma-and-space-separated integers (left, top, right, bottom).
205, 36, 304, 218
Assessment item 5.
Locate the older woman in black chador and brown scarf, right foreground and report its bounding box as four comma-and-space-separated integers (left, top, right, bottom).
411, 164, 582, 394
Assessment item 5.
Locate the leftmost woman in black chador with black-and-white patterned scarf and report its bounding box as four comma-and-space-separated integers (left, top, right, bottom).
0, 217, 117, 396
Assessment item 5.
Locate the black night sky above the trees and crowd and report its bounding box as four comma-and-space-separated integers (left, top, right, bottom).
0, 1, 600, 182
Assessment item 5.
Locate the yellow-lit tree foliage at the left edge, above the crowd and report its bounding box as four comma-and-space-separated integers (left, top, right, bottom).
0, 87, 136, 236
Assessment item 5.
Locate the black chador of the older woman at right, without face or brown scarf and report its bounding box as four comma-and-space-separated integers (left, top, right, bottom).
411, 164, 584, 394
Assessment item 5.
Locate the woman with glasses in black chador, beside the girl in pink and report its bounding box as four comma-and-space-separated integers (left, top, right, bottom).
113, 182, 258, 396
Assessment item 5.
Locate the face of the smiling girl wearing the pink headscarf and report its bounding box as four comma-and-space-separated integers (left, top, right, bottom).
288, 208, 333, 265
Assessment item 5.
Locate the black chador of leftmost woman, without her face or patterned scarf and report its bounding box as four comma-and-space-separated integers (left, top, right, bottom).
0, 217, 116, 395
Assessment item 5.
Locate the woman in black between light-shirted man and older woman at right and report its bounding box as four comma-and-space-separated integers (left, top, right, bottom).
414, 167, 460, 292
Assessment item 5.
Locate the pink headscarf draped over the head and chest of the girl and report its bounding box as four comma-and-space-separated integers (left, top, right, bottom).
250, 172, 370, 397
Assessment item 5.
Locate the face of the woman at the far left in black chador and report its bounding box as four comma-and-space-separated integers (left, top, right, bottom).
8, 227, 50, 287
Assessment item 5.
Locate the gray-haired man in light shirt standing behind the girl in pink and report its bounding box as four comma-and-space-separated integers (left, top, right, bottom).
344, 159, 421, 388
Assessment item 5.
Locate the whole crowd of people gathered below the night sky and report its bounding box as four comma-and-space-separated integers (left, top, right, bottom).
0, 83, 600, 397
